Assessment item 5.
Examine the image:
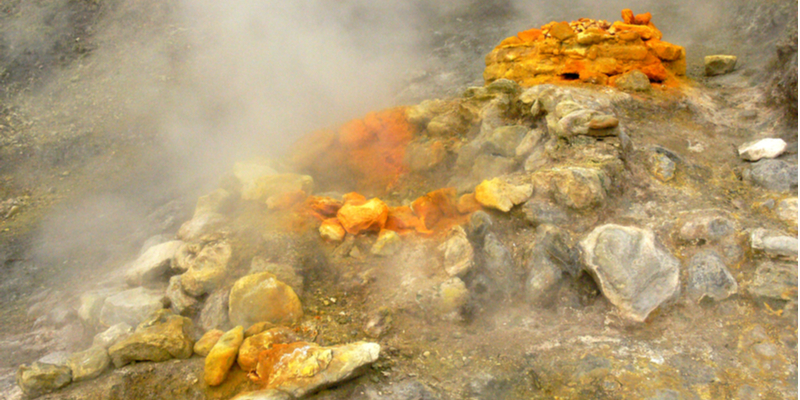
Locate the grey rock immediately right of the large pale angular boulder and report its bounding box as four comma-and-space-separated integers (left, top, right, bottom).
687, 251, 739, 302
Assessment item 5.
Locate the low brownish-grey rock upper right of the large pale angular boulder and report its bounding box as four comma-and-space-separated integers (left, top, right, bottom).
678, 209, 738, 244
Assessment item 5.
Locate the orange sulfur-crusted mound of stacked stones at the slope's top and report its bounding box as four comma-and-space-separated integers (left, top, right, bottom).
483, 9, 686, 86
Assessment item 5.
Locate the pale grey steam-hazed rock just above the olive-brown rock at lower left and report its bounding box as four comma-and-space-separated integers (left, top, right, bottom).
100, 287, 164, 326
